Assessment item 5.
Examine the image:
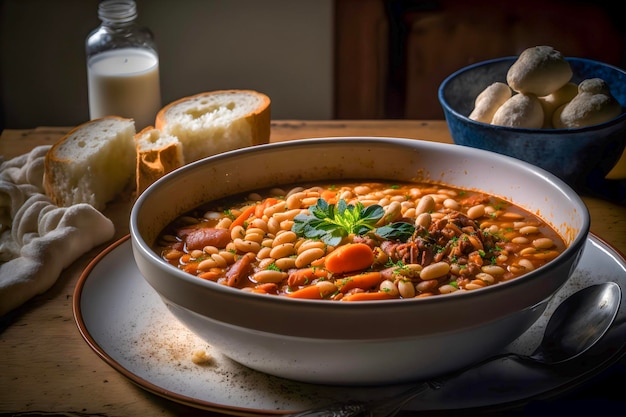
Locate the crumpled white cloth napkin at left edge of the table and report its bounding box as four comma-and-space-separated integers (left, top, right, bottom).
0, 145, 115, 316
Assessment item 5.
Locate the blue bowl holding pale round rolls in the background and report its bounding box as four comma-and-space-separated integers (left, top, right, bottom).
438, 57, 626, 191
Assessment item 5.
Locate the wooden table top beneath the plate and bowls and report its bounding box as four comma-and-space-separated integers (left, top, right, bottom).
0, 120, 626, 416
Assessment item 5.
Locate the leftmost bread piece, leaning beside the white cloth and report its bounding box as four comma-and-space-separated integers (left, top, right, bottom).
43, 116, 136, 211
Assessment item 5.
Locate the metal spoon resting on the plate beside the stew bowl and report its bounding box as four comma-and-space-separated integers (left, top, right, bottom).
291, 282, 622, 417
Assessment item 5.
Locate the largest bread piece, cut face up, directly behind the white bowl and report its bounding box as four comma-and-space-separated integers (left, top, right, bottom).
155, 90, 270, 163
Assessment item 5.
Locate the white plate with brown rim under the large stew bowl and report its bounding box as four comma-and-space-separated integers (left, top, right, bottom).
74, 235, 626, 416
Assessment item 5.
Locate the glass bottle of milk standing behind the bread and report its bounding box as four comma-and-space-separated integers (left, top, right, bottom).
86, 0, 161, 131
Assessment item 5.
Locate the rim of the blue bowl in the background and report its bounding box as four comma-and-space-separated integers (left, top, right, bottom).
437, 56, 626, 132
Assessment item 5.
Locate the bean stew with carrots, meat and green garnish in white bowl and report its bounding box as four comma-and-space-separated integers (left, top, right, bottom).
155, 181, 566, 301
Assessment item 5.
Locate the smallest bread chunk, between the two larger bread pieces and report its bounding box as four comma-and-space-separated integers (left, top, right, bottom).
135, 126, 185, 195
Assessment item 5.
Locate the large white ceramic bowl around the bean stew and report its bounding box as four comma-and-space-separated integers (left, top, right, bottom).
130, 138, 589, 385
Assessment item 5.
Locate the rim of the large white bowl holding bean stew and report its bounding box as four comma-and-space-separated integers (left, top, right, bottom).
129, 136, 591, 311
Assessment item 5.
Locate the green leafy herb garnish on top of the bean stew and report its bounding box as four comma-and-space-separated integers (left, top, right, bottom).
291, 198, 415, 246
